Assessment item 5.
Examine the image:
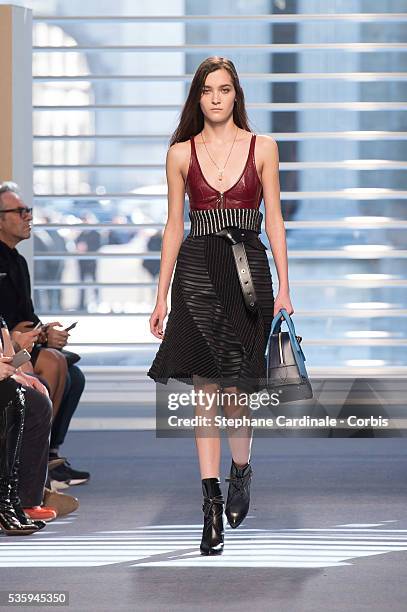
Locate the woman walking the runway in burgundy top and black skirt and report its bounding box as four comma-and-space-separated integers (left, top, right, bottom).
148, 56, 294, 554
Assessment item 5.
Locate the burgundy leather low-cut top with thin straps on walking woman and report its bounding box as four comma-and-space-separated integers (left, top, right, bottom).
185, 134, 263, 210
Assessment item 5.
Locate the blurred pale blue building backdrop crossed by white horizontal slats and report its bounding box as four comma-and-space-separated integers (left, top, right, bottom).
33, 0, 407, 374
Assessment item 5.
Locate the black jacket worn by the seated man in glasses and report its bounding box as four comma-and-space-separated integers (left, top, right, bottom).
0, 240, 40, 330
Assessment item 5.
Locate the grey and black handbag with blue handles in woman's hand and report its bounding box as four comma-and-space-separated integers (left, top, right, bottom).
266, 308, 313, 404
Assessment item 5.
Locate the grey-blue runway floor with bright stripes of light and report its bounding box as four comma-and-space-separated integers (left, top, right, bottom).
0, 431, 407, 612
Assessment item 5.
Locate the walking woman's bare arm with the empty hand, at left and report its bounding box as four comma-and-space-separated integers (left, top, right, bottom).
150, 144, 185, 338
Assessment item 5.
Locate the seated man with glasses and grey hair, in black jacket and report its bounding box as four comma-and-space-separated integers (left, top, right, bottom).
0, 183, 90, 484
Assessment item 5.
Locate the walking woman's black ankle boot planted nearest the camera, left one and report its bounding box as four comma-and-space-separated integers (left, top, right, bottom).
200, 478, 224, 555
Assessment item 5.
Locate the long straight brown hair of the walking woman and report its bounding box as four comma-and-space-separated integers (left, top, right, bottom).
169, 55, 252, 146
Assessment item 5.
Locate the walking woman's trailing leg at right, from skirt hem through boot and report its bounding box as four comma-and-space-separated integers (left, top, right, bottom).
222, 387, 253, 528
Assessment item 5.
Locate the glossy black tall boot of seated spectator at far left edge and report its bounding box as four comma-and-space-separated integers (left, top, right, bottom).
0, 378, 38, 535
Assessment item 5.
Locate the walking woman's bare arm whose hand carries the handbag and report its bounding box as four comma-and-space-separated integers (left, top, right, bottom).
261, 136, 294, 314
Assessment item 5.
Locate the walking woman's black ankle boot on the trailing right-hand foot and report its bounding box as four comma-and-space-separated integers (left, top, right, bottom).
225, 459, 252, 529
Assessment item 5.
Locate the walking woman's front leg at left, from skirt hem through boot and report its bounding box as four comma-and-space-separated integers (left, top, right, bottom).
194, 376, 225, 555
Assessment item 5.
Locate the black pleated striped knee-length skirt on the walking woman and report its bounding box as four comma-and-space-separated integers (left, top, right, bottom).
147, 225, 274, 393
